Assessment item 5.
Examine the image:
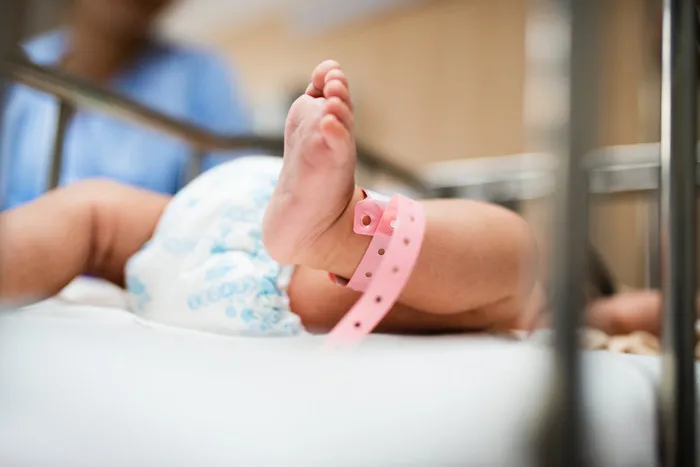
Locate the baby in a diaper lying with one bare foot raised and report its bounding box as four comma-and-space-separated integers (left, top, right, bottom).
0, 61, 556, 335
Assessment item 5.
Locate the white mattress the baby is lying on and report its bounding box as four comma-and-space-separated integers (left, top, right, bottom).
0, 280, 676, 467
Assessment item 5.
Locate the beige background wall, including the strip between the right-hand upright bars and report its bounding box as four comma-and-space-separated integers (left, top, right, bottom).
212, 0, 657, 284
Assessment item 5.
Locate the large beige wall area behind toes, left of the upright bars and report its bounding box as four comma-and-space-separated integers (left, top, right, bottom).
216, 0, 525, 166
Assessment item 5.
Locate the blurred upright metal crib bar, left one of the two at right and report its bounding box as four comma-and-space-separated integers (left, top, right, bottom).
526, 0, 601, 467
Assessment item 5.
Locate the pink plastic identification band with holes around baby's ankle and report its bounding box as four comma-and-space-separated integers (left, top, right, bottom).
325, 188, 425, 348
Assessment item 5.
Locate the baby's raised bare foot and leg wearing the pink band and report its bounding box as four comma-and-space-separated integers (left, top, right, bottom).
263, 62, 536, 327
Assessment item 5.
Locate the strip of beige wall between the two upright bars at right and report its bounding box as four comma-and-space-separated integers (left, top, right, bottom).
591, 0, 658, 285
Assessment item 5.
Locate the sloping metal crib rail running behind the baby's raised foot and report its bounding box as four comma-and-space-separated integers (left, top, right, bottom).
8, 56, 430, 194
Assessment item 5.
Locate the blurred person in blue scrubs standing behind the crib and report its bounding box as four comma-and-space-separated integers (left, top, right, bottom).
0, 0, 251, 209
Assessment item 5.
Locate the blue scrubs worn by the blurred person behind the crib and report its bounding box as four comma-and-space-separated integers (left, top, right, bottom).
0, 32, 252, 209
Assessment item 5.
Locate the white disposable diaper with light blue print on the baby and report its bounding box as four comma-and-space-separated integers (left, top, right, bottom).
126, 156, 303, 336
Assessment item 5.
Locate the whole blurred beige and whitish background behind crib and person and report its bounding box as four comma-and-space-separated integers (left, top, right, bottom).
6, 0, 680, 285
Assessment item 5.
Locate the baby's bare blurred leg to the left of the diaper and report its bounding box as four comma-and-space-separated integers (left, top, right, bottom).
0, 180, 169, 303
